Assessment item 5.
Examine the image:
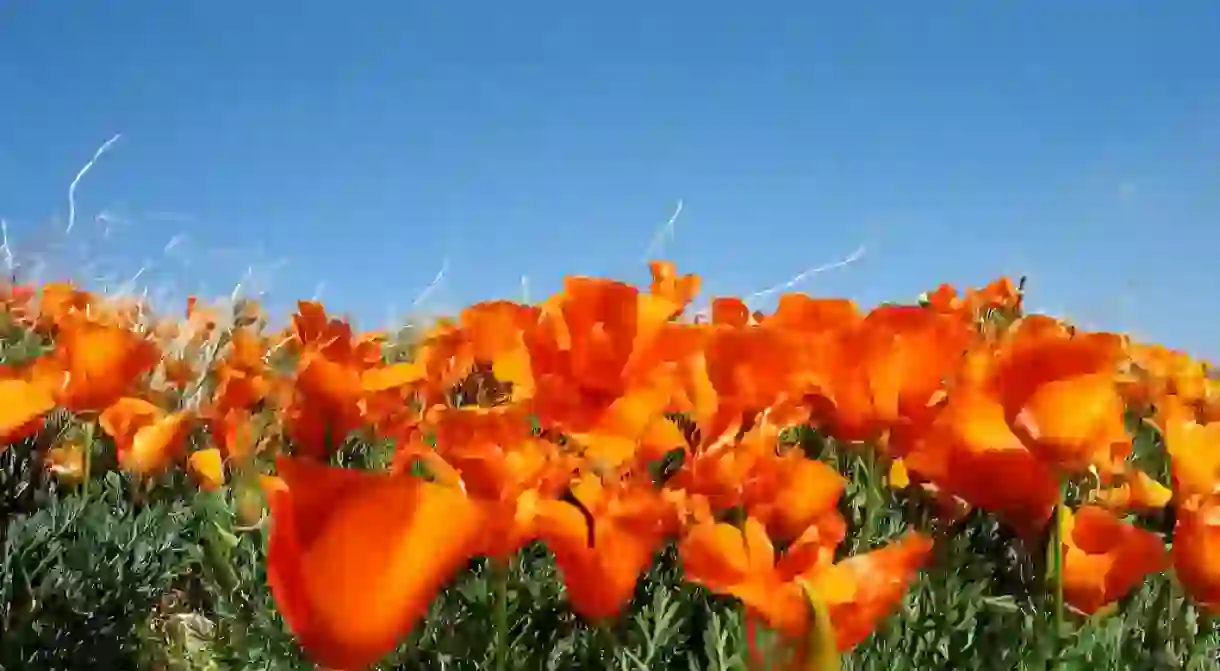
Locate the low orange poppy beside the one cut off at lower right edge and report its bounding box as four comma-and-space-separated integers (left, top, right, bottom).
1060, 505, 1169, 615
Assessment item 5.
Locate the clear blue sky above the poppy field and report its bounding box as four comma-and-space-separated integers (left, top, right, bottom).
0, 0, 1220, 355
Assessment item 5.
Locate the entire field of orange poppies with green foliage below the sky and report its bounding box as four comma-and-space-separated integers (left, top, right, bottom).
0, 261, 1220, 671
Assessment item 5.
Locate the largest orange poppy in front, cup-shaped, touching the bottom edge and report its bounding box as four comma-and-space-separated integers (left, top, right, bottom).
266, 458, 484, 669
